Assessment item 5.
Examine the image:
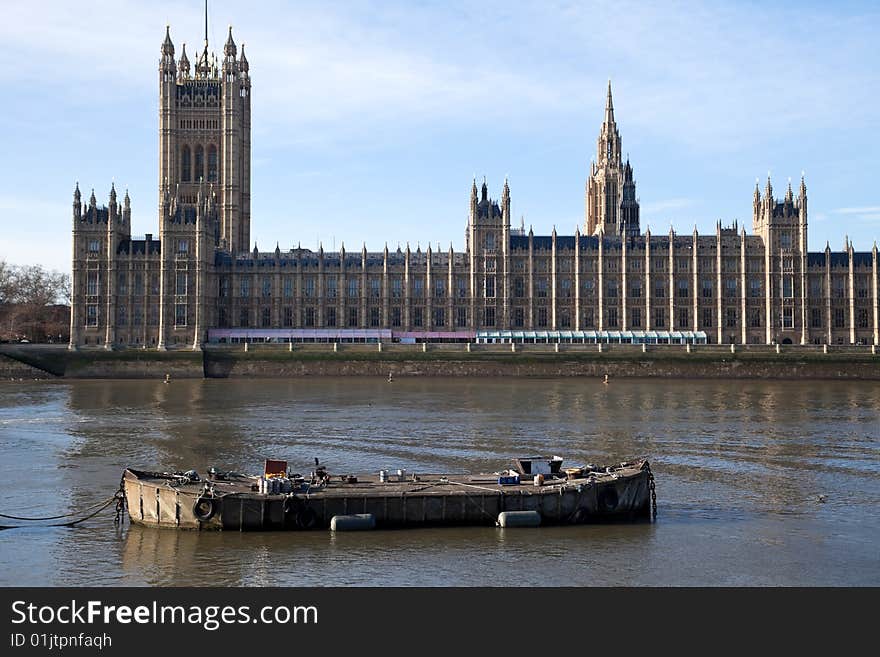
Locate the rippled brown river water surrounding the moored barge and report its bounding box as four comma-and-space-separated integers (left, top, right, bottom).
0, 378, 880, 586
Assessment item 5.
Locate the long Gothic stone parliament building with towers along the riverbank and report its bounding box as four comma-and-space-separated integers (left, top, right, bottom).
70, 19, 880, 350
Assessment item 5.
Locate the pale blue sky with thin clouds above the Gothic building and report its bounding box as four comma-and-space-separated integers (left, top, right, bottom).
0, 0, 880, 271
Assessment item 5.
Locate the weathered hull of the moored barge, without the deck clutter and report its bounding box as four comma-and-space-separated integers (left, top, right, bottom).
124, 461, 652, 531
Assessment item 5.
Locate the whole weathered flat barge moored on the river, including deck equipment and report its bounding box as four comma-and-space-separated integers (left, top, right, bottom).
122, 457, 656, 531
